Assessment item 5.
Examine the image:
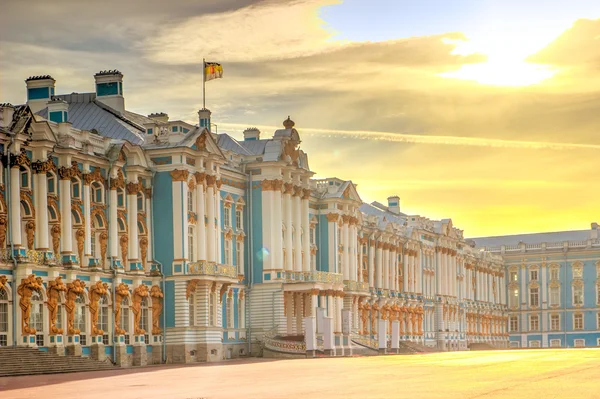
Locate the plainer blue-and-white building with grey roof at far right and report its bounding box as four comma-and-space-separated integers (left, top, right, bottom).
474, 223, 600, 348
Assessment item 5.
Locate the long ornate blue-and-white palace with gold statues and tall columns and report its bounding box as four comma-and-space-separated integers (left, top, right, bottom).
0, 70, 510, 366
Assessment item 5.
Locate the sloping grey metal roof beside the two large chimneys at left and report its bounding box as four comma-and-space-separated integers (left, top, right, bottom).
37, 93, 145, 144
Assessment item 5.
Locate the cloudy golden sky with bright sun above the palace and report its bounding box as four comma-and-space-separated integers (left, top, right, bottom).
0, 0, 600, 237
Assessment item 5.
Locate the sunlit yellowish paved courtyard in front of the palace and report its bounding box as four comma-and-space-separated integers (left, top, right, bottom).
0, 349, 600, 399
